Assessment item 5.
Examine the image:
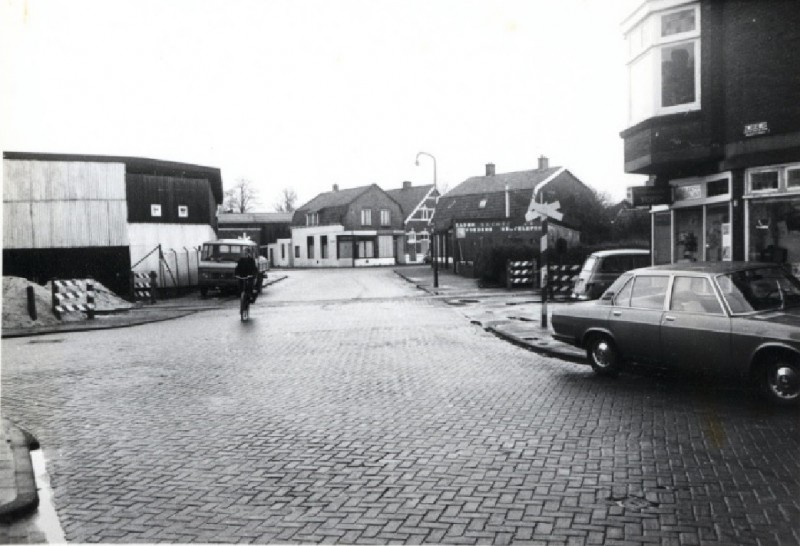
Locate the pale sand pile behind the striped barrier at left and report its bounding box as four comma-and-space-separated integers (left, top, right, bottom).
3, 277, 133, 328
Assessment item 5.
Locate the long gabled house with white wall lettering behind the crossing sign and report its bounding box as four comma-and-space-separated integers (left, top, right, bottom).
432, 157, 596, 265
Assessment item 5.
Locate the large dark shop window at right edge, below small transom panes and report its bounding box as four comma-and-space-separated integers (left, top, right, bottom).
748, 198, 800, 275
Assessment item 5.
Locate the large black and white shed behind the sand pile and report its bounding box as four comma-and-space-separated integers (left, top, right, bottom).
3, 152, 222, 294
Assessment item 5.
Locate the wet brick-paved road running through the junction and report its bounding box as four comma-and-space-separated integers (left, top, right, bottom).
2, 270, 800, 544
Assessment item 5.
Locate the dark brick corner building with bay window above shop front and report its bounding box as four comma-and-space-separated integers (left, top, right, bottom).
621, 0, 800, 275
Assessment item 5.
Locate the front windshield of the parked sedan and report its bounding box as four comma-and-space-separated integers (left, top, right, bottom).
717, 267, 800, 313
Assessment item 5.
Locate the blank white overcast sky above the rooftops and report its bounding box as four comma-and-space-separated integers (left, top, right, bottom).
0, 0, 642, 211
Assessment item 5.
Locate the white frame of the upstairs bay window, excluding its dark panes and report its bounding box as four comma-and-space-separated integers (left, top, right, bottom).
625, 2, 703, 125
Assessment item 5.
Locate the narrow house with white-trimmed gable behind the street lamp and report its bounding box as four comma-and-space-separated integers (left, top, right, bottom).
386, 181, 439, 264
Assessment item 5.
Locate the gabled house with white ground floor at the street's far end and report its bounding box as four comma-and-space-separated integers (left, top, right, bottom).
290, 184, 404, 267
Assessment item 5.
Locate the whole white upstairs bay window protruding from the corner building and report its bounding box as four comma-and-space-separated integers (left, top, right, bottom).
624, 1, 700, 125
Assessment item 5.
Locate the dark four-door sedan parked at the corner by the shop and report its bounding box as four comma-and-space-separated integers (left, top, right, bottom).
552, 262, 800, 405
